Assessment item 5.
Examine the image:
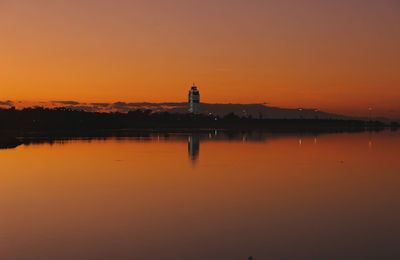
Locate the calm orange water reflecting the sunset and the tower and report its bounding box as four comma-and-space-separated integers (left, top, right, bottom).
0, 132, 400, 260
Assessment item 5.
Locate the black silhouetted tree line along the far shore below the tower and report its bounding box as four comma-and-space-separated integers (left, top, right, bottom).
0, 107, 392, 135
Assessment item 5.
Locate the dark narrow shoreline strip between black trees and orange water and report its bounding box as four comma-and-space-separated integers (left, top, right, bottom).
0, 127, 398, 149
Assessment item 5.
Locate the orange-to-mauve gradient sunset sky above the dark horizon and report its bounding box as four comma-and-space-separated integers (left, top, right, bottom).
0, 0, 400, 117
